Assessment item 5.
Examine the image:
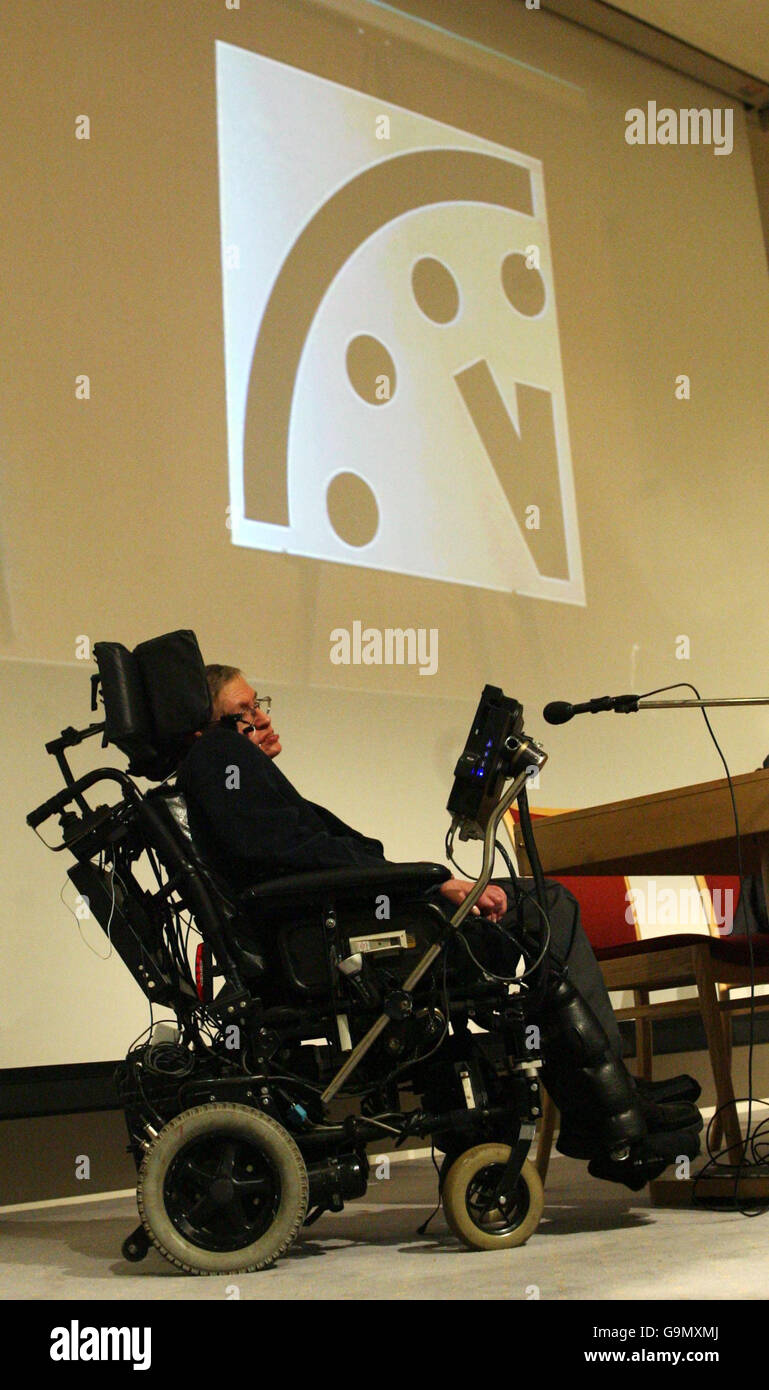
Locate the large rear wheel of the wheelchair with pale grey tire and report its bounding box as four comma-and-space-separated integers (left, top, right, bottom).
136, 1101, 309, 1275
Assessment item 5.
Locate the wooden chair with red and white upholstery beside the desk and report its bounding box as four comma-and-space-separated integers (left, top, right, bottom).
506, 810, 769, 1180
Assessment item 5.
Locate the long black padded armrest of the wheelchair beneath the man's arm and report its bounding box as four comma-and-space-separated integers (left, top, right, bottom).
238, 863, 451, 908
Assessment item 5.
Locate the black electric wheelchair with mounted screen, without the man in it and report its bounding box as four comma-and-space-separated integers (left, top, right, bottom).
26, 631, 547, 1275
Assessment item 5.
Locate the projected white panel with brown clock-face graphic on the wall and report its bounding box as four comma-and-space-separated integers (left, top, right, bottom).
217, 43, 584, 603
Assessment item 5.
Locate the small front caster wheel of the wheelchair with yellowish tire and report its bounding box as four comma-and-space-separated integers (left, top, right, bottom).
442, 1144, 545, 1250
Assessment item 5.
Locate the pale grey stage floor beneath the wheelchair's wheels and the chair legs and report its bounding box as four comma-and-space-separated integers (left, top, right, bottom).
0, 1158, 769, 1301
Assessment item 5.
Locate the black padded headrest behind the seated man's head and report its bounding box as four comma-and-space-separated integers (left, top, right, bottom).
93, 630, 211, 781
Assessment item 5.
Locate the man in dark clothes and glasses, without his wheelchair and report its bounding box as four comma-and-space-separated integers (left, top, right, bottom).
177, 666, 702, 1182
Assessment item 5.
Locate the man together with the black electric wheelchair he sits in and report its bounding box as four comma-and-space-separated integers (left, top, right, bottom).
26, 631, 702, 1273
